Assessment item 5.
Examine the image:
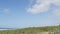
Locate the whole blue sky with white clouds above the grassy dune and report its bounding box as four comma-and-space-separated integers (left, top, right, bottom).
0, 0, 60, 28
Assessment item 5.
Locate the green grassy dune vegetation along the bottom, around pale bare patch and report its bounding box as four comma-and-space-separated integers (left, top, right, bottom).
0, 26, 60, 34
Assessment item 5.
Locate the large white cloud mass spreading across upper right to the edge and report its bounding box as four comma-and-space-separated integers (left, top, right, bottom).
27, 0, 60, 15
